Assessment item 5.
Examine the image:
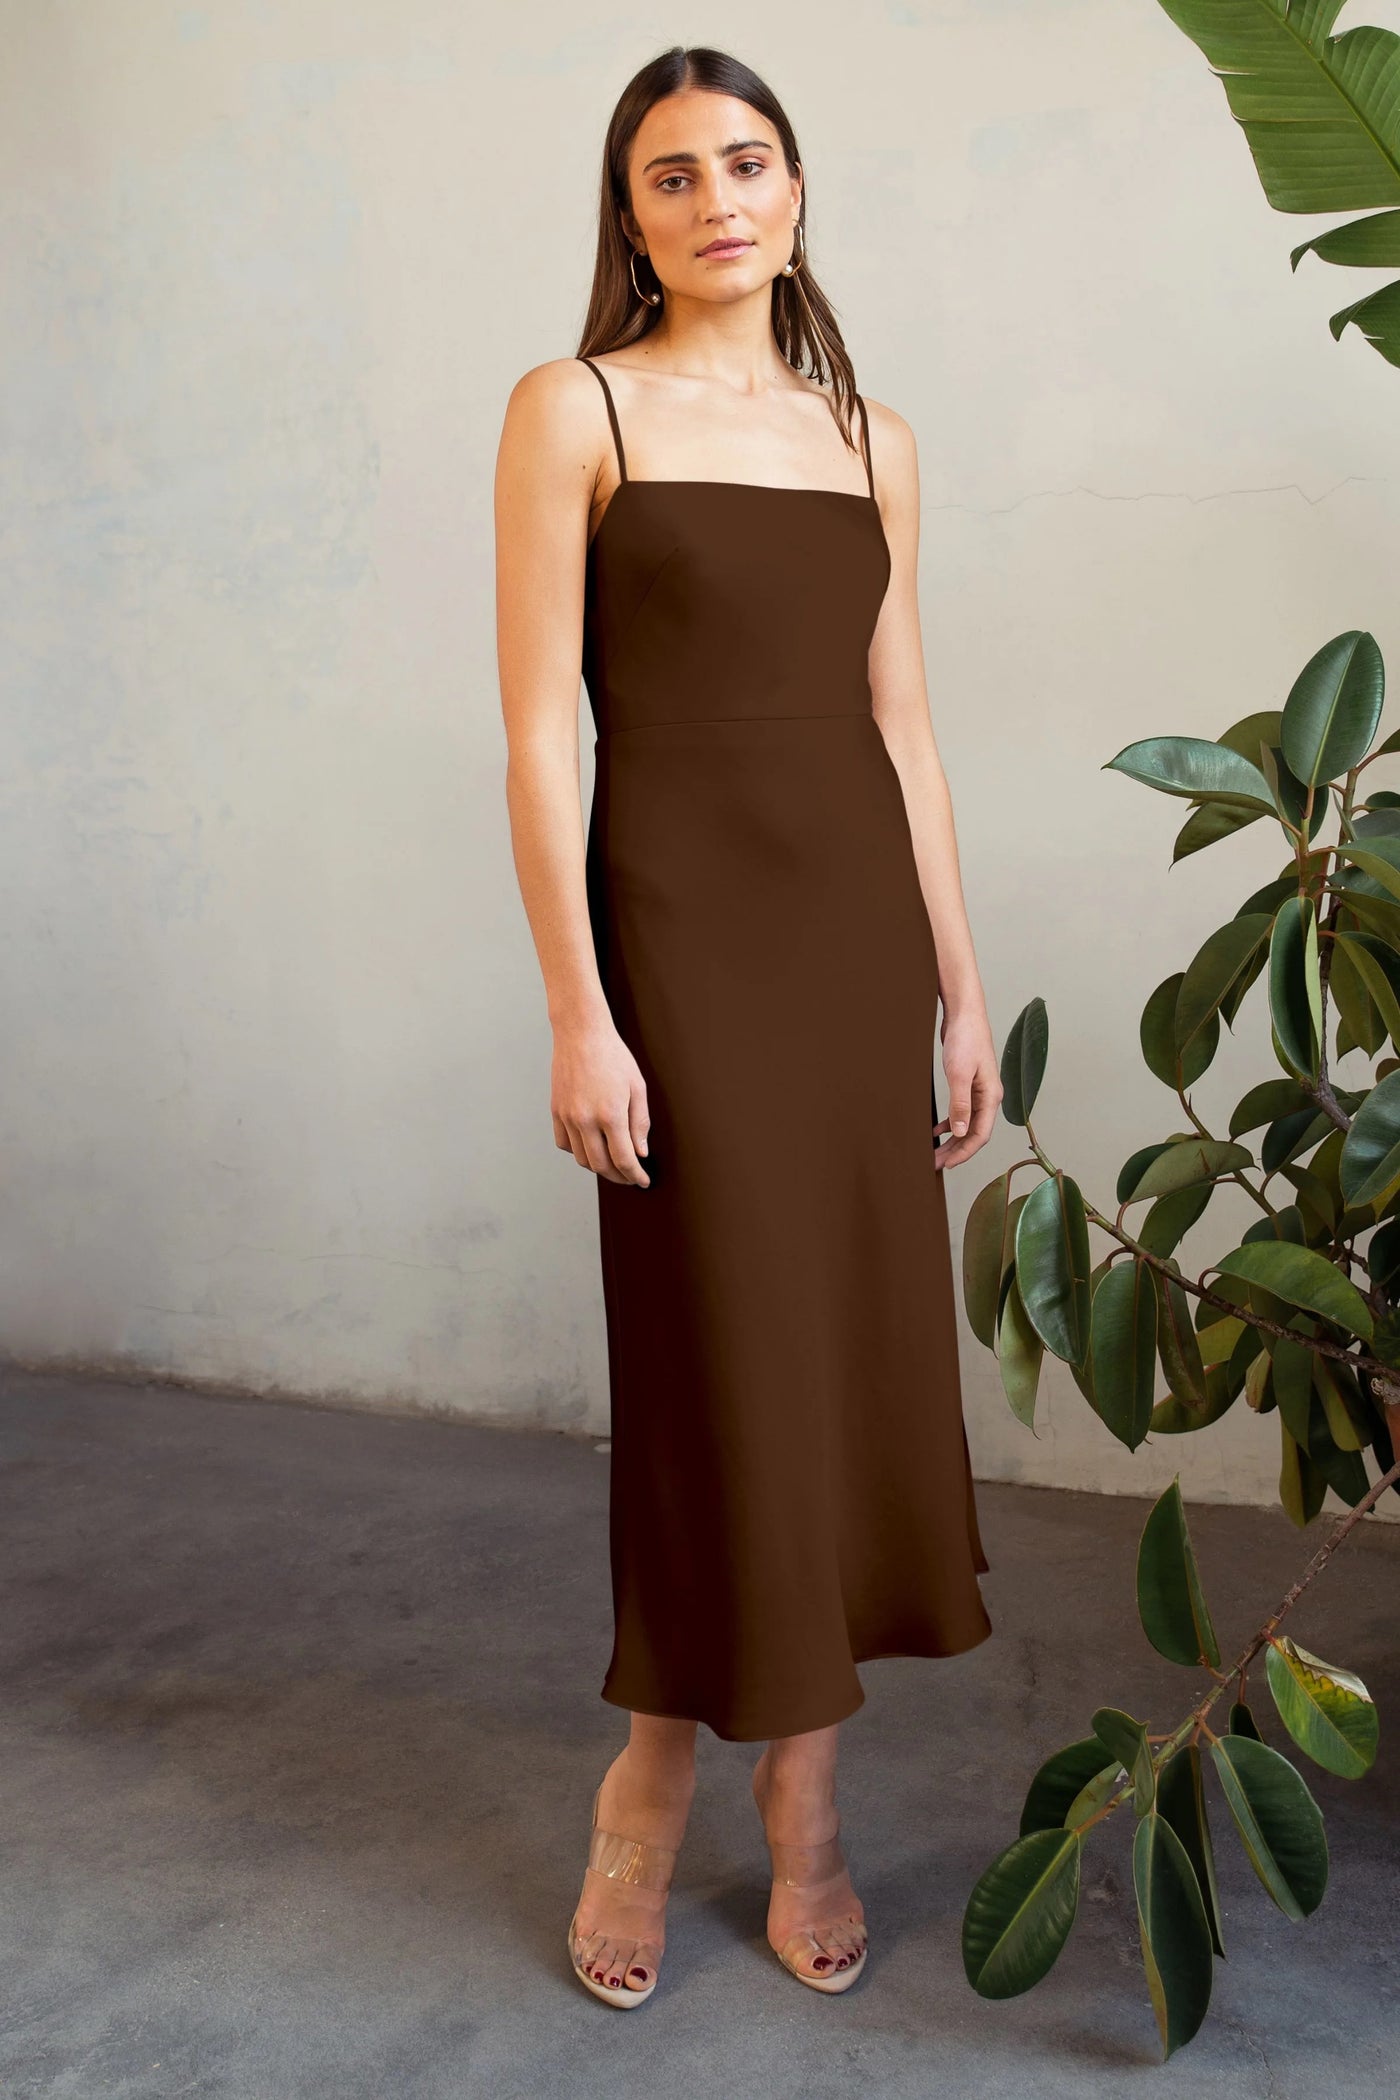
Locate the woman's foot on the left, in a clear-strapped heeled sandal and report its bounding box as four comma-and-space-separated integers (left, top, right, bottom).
573, 1745, 695, 1991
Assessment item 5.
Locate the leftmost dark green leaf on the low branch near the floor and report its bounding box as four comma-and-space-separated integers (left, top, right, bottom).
963, 1829, 1081, 1997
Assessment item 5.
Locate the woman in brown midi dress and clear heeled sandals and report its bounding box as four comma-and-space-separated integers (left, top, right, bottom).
497, 50, 1001, 2008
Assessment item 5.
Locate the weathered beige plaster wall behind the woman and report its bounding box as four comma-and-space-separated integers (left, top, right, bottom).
0, 0, 1400, 1528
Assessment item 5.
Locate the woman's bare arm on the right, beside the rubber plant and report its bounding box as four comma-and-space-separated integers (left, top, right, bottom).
867, 401, 1001, 1168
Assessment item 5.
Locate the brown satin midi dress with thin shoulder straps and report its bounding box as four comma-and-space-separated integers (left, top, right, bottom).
584, 359, 991, 1741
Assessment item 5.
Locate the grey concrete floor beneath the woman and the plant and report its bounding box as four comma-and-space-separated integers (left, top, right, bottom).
0, 1373, 1400, 2100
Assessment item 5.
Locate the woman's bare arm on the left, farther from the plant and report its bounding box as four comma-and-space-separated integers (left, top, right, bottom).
495, 359, 649, 1187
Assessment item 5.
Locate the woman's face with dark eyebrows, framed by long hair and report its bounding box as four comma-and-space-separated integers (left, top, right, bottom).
623, 88, 802, 302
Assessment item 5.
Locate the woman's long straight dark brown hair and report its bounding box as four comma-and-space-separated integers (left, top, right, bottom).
577, 44, 856, 449
